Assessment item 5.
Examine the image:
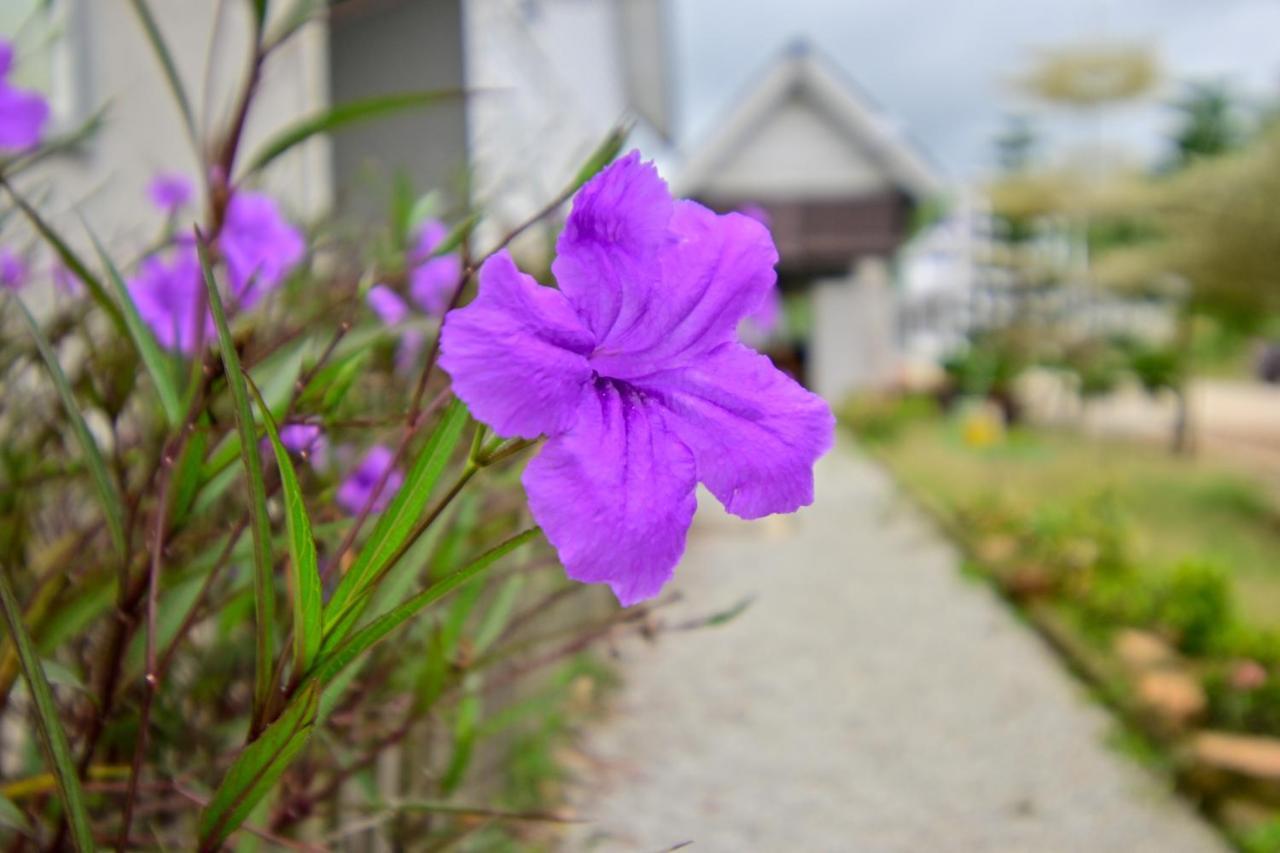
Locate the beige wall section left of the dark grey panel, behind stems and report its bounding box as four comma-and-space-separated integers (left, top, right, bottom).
10, 0, 330, 248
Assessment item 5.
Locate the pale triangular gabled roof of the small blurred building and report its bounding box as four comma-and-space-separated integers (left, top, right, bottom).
677, 42, 941, 199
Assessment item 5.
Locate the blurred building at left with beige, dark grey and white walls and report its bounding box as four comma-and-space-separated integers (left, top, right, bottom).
0, 0, 671, 256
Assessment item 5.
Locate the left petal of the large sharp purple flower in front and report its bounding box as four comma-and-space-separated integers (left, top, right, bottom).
440, 251, 595, 438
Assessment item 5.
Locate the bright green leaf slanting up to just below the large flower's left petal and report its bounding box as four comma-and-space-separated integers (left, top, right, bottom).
325, 400, 467, 637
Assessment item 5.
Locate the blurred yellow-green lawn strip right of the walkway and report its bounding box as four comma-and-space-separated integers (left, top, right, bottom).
878, 419, 1280, 628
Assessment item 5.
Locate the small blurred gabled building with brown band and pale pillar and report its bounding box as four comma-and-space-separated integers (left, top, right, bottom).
678, 42, 940, 401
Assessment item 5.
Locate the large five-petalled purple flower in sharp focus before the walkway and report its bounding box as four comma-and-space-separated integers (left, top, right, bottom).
440, 152, 835, 605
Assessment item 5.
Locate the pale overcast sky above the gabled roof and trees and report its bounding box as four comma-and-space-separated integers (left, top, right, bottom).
671, 0, 1280, 178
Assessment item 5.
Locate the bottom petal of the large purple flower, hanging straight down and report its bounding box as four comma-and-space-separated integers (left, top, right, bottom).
524, 380, 696, 607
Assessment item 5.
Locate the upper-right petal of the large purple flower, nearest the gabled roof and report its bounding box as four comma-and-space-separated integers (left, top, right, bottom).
591, 201, 778, 379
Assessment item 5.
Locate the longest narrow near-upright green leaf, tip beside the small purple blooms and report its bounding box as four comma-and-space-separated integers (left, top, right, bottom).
196, 237, 275, 721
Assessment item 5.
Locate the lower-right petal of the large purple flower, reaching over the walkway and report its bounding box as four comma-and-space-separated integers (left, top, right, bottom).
636, 342, 835, 519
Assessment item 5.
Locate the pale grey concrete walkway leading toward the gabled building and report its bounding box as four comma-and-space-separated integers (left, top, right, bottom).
566, 438, 1224, 853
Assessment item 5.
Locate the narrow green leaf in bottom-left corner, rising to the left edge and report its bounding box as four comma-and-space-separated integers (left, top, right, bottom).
0, 570, 93, 850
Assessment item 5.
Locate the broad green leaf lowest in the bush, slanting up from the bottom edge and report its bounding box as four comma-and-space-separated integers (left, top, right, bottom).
198, 685, 320, 850
